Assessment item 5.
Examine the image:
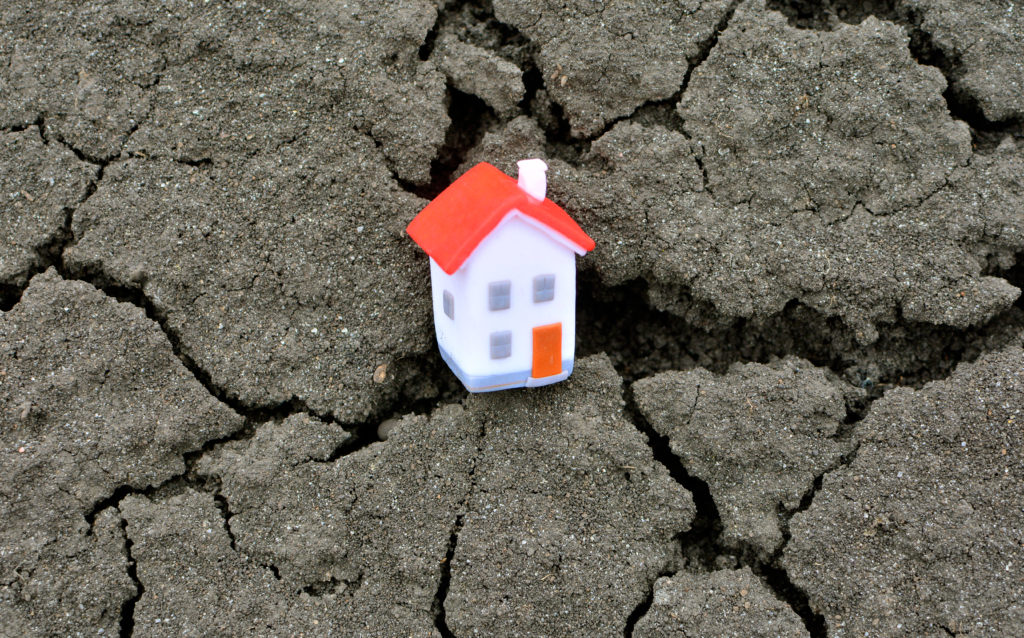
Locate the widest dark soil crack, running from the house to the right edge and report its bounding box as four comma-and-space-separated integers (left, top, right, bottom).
577, 276, 1024, 391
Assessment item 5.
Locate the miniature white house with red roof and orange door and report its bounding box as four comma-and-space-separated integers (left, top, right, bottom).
408, 160, 594, 392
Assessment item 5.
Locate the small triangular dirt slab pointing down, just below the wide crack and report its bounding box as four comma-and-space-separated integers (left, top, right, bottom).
633, 357, 858, 559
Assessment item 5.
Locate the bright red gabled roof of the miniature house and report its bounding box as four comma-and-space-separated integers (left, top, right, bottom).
406, 162, 594, 274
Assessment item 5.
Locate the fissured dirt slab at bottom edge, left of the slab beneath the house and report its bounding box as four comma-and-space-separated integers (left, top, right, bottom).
126, 406, 477, 636
